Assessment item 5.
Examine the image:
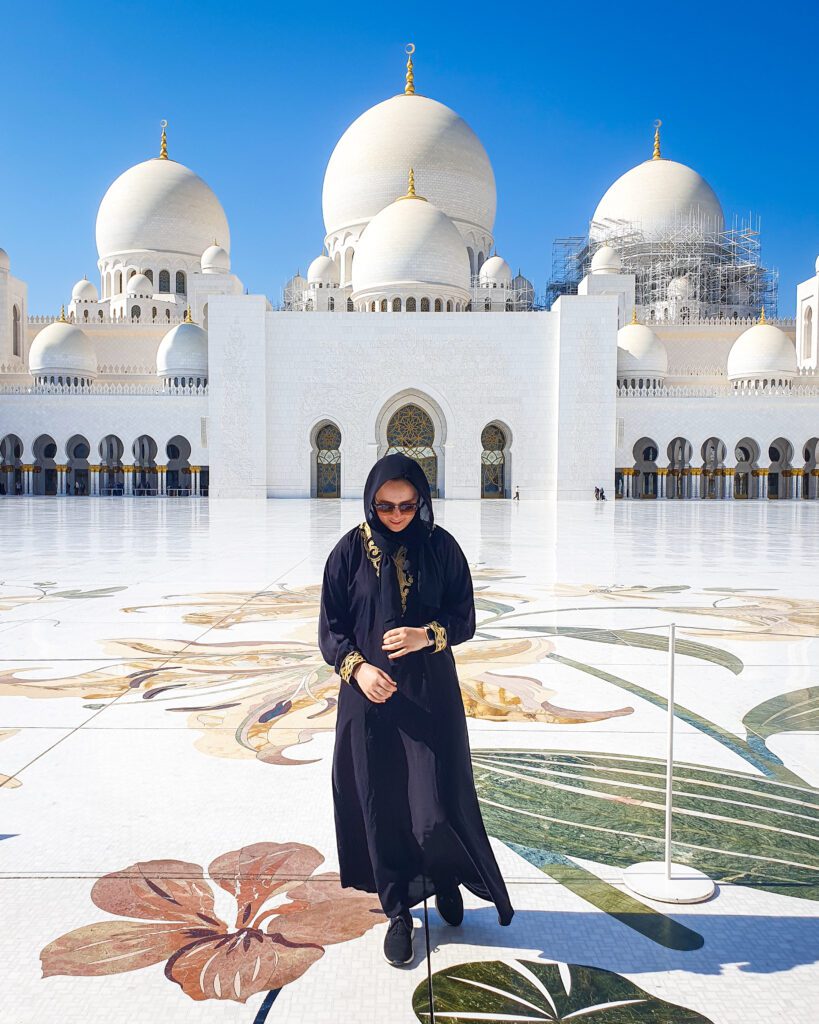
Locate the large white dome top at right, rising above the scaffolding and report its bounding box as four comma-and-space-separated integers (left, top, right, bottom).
590, 159, 725, 241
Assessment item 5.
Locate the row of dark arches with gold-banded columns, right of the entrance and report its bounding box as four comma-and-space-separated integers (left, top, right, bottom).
615, 436, 819, 501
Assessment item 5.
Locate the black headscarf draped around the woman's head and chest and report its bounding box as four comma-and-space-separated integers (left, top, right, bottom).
364, 453, 443, 630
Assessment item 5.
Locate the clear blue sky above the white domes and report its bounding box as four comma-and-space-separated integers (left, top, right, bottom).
0, 0, 819, 315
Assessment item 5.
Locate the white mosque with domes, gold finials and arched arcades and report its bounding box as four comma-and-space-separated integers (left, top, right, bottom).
0, 47, 819, 500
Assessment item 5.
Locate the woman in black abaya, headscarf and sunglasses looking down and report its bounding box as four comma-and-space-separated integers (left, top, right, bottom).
318, 455, 514, 966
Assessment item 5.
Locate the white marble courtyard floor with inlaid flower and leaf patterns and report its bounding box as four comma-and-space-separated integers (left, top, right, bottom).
0, 499, 819, 1024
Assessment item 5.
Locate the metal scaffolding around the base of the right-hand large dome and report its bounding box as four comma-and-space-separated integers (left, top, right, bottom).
547, 209, 779, 323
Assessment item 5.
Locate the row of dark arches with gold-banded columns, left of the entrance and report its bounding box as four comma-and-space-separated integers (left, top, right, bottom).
0, 434, 208, 498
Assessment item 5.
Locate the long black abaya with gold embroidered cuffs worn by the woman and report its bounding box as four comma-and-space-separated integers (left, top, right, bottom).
318, 512, 514, 925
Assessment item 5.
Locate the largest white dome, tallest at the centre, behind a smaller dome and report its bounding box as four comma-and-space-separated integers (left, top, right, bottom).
321, 95, 497, 242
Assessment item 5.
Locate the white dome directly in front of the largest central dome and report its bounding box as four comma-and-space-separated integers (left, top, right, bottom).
352, 189, 471, 300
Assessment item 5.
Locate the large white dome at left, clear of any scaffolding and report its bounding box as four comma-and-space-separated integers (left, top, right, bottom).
96, 157, 230, 259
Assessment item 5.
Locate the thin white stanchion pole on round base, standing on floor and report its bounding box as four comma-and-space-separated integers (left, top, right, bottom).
622, 623, 716, 903
